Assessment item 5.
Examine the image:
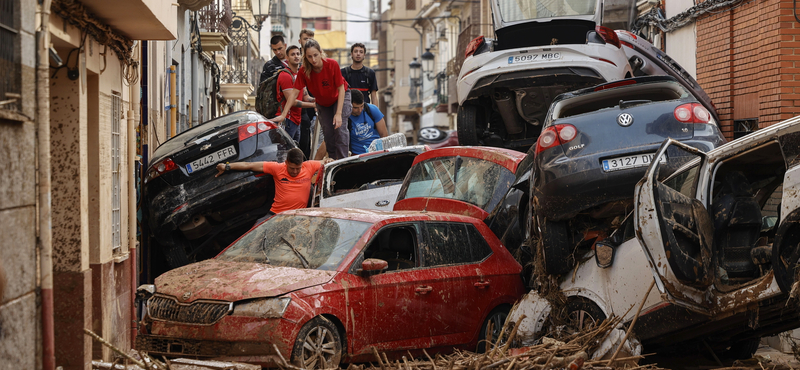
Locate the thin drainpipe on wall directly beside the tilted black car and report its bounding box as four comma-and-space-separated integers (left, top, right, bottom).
127, 41, 141, 348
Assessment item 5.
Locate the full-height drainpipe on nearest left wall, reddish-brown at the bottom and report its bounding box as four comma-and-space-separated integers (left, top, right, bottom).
36, 0, 56, 370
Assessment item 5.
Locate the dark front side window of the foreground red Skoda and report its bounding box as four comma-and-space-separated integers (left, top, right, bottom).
350, 224, 419, 274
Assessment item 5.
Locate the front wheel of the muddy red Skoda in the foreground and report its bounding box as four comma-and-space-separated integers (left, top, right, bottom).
292, 316, 342, 369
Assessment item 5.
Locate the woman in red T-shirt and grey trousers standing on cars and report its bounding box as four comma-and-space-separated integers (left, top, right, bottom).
273, 39, 352, 159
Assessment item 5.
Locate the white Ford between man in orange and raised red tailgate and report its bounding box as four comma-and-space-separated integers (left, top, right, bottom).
316, 145, 427, 210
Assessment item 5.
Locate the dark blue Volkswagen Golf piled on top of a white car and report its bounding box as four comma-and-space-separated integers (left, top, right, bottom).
532, 76, 725, 274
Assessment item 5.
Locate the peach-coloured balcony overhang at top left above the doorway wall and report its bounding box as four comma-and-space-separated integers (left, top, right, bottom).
61, 0, 178, 40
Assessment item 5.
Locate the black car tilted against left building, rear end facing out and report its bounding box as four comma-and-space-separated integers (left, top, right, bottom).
144, 111, 295, 276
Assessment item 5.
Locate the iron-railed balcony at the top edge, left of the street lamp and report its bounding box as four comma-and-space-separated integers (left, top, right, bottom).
197, 0, 233, 51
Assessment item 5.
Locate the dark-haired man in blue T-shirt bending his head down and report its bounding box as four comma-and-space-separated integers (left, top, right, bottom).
349, 89, 389, 155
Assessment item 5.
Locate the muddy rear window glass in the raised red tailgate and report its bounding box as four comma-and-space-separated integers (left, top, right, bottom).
397, 156, 514, 212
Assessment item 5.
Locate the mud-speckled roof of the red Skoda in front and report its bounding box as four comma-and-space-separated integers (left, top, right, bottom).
280, 208, 480, 223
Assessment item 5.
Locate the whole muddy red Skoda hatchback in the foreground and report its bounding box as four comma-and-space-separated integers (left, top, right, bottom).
136, 208, 524, 368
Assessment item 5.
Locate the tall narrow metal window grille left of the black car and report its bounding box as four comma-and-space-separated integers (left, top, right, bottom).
111, 91, 122, 253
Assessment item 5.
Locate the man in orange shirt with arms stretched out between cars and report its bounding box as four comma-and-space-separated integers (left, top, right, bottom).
215, 148, 331, 225
